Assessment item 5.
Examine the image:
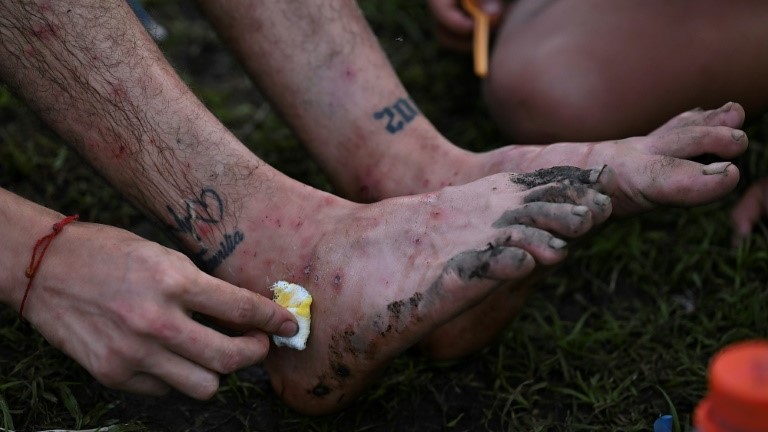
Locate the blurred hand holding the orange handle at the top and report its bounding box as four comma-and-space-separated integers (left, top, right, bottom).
427, 0, 506, 51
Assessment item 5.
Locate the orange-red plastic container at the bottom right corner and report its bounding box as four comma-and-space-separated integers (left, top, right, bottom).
693, 340, 768, 432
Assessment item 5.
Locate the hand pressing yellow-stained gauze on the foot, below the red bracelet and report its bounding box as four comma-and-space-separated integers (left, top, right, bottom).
24, 223, 297, 399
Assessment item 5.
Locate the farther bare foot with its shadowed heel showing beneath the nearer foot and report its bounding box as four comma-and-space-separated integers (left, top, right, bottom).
404, 103, 754, 358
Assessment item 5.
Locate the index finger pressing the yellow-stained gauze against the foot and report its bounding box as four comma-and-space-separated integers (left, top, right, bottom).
182, 273, 298, 337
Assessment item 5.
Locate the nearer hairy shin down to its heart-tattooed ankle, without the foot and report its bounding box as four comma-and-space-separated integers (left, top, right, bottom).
0, 0, 272, 268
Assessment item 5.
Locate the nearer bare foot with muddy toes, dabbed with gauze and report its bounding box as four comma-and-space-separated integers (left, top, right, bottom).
216, 167, 614, 414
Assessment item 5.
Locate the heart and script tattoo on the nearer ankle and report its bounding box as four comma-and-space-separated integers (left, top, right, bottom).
166, 188, 245, 271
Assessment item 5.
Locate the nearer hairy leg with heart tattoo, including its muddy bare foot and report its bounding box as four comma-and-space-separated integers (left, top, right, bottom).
0, 0, 617, 413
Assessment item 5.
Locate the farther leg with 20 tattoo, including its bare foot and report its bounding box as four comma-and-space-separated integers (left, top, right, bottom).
202, 0, 746, 357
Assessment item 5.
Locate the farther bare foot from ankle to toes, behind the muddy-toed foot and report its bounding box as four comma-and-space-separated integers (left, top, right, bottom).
356, 102, 747, 216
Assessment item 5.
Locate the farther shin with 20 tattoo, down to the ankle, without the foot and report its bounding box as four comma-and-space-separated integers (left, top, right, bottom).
200, 0, 459, 195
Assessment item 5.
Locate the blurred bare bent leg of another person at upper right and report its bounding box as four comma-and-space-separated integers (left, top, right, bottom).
486, 0, 768, 143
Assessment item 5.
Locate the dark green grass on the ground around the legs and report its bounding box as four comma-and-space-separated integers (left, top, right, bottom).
0, 0, 768, 431
